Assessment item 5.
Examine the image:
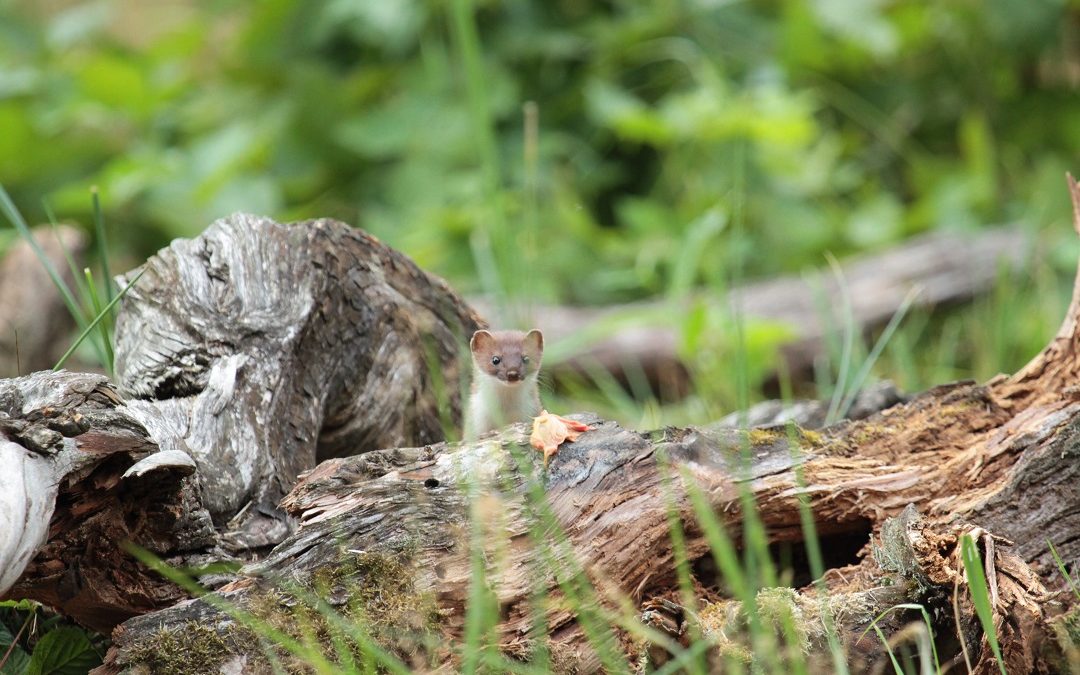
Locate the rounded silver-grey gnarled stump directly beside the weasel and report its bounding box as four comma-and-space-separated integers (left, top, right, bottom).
116, 214, 480, 550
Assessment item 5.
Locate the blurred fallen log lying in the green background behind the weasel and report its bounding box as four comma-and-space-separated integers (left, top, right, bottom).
473, 226, 1030, 397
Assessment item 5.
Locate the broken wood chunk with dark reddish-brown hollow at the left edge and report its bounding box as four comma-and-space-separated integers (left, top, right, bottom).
0, 372, 213, 631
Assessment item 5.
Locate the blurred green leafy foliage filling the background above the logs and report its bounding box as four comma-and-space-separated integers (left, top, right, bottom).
0, 0, 1080, 416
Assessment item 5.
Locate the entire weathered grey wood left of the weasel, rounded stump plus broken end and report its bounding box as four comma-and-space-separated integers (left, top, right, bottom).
0, 215, 478, 632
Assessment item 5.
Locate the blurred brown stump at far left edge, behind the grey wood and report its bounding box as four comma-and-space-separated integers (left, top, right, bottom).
0, 225, 86, 377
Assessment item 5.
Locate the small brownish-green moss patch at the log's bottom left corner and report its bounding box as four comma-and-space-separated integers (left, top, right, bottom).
123, 621, 255, 675
